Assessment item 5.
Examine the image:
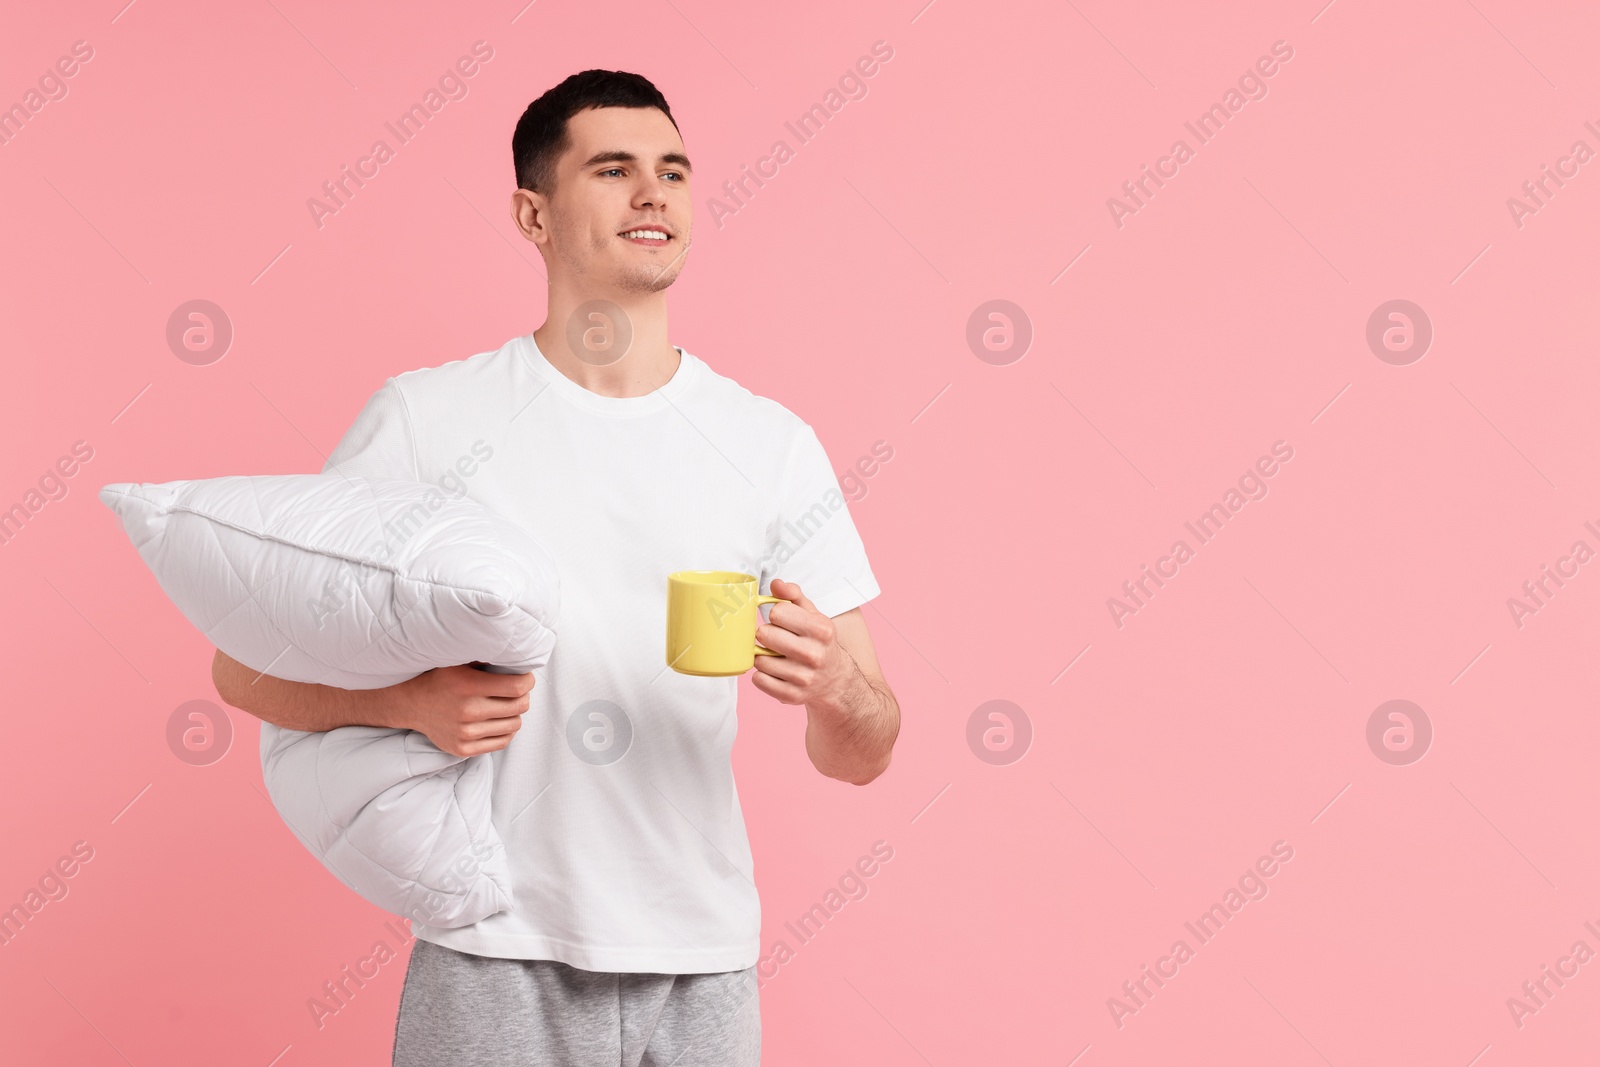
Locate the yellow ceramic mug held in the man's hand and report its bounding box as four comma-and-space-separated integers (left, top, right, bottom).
667, 571, 790, 678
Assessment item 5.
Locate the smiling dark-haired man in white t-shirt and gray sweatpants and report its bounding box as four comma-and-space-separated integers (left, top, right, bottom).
213, 70, 899, 1067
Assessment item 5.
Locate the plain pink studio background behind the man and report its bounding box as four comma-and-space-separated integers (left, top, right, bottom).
0, 0, 1600, 1067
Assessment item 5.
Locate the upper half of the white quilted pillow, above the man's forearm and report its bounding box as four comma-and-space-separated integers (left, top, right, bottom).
99, 474, 558, 689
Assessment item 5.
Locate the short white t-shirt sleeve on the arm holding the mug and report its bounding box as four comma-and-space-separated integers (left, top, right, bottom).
760, 424, 878, 617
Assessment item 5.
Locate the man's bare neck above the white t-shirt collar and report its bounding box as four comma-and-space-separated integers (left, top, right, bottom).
533, 290, 680, 397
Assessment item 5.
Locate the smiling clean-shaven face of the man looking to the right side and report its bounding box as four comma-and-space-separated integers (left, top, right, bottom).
549, 107, 693, 294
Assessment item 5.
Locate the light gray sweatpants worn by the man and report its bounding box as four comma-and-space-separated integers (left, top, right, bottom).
394, 937, 762, 1067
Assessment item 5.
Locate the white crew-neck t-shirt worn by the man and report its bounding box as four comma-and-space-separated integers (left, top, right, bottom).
323, 334, 878, 974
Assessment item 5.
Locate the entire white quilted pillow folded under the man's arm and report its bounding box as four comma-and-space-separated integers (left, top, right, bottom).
99, 474, 560, 926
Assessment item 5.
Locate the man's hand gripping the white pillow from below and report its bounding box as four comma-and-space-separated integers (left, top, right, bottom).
386, 664, 534, 757
